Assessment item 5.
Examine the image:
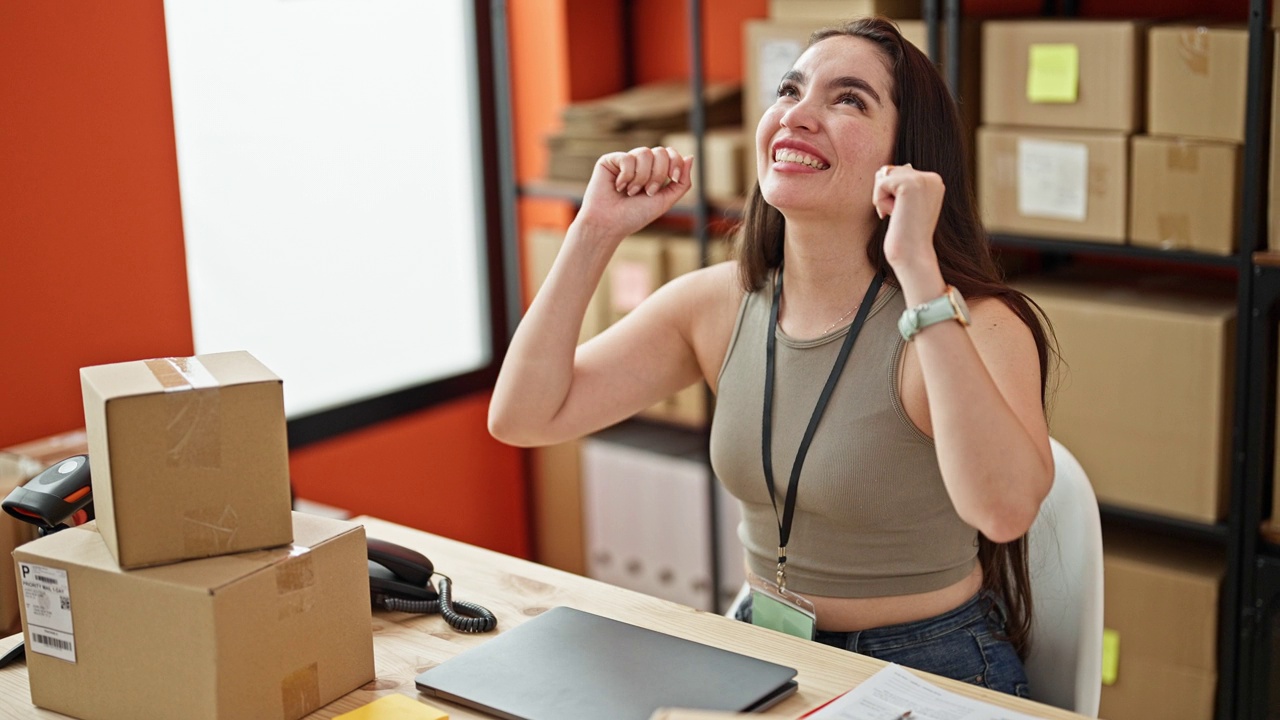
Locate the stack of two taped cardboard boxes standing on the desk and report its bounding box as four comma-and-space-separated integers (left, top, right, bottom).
14, 352, 374, 720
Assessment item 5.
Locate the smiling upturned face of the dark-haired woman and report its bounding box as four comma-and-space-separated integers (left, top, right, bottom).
755, 36, 897, 220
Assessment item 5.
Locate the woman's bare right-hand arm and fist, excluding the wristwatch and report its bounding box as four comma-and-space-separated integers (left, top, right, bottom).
872, 165, 1053, 542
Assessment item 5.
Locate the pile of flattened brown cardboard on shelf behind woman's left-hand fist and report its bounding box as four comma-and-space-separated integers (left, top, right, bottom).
547, 82, 741, 182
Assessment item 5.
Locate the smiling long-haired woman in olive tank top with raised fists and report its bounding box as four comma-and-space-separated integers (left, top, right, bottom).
489, 19, 1053, 694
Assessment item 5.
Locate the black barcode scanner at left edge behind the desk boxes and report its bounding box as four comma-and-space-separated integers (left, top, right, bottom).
0, 455, 93, 533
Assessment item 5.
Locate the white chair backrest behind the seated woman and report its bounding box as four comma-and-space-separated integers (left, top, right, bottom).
1027, 438, 1102, 717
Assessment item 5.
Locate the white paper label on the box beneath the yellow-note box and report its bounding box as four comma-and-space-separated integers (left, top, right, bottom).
1018, 140, 1089, 223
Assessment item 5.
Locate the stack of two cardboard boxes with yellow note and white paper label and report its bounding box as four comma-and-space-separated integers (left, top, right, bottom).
978, 19, 1146, 243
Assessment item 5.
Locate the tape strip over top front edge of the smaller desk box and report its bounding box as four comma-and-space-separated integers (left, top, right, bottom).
145, 357, 223, 469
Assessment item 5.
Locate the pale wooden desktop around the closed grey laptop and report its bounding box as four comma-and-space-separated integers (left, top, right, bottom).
0, 518, 1083, 720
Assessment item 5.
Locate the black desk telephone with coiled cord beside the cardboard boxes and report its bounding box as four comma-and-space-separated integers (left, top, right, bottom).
367, 538, 498, 633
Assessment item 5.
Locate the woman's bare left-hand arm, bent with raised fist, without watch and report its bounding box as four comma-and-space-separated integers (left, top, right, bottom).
489, 149, 699, 446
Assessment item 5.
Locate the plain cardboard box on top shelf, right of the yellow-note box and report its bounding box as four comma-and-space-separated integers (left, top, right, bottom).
1147, 26, 1249, 143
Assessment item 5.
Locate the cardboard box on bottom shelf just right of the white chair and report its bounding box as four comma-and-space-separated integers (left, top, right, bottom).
1098, 533, 1225, 720
